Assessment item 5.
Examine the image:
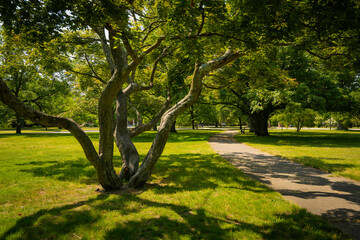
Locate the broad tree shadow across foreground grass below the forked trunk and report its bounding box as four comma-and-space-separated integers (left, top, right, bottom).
0, 190, 344, 239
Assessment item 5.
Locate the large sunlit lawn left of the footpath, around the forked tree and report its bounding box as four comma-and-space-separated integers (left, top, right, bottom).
0, 130, 346, 239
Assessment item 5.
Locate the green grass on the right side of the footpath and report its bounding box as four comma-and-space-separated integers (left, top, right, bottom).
236, 130, 360, 181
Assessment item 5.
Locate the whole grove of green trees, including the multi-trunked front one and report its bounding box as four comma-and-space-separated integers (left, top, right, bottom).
0, 0, 360, 190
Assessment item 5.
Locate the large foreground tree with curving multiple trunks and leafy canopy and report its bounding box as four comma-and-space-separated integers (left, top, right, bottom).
0, 0, 358, 190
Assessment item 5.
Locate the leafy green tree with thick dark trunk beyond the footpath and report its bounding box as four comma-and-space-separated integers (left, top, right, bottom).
205, 48, 295, 136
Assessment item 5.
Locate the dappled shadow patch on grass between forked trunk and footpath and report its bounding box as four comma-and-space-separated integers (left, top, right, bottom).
153, 154, 272, 193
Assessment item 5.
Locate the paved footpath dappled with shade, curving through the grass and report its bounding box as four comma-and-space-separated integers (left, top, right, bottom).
209, 131, 360, 240
